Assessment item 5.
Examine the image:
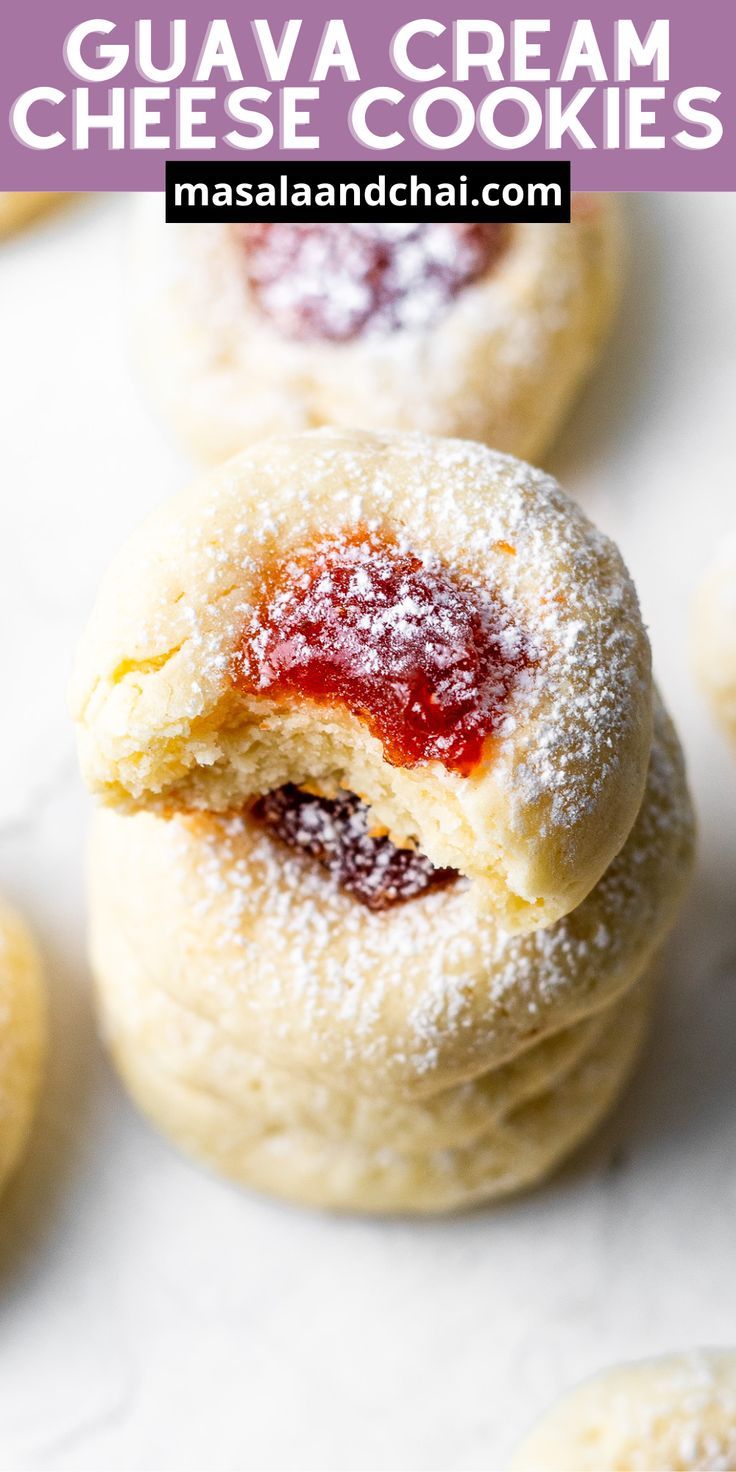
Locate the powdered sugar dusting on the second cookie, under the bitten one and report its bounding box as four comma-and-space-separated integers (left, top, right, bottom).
146, 694, 692, 1079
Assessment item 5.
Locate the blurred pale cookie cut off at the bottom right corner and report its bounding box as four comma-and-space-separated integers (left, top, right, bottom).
509, 1350, 736, 1472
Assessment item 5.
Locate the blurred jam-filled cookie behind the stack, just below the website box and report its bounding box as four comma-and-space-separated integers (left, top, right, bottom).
132, 194, 620, 461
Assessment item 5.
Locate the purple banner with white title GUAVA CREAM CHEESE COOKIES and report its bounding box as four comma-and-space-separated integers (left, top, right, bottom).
0, 0, 736, 190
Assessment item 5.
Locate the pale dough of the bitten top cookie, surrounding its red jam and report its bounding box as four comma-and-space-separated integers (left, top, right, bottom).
78, 431, 651, 918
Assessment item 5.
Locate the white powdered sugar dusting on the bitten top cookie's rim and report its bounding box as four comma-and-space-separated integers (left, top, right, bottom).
193, 431, 649, 832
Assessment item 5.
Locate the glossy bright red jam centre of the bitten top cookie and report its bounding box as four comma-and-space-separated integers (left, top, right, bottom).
231, 530, 534, 776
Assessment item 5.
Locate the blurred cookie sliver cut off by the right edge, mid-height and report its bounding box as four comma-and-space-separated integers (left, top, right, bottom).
695, 539, 736, 746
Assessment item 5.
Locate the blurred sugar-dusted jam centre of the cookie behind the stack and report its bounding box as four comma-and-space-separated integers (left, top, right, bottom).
234, 222, 508, 342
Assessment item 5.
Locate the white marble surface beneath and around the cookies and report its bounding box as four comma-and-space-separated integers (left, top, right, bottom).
0, 196, 736, 1472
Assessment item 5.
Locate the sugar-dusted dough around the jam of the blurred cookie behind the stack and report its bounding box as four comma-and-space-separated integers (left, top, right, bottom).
137, 199, 611, 458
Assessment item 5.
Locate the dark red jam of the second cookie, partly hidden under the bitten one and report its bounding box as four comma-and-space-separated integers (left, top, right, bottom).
250, 783, 458, 910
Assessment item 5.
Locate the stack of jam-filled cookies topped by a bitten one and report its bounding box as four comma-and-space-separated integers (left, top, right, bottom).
74, 430, 692, 1211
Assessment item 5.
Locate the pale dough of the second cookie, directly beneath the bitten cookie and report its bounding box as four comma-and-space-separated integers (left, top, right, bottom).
90, 694, 693, 1101
